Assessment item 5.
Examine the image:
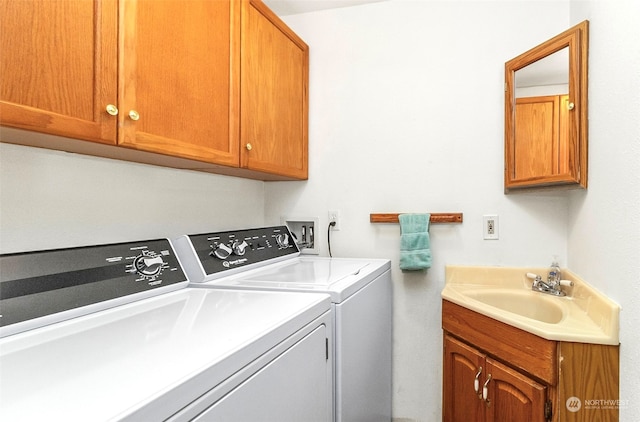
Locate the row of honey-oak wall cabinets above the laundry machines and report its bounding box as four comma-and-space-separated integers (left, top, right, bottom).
0, 0, 309, 180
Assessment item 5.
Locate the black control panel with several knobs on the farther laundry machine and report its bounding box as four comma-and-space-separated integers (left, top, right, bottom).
188, 226, 300, 275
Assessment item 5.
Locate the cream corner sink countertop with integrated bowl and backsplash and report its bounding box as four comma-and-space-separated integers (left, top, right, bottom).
442, 266, 620, 345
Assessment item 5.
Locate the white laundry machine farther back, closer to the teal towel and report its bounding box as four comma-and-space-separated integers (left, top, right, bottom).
174, 226, 392, 422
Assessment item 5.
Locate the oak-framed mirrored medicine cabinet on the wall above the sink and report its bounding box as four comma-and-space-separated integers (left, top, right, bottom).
504, 21, 589, 192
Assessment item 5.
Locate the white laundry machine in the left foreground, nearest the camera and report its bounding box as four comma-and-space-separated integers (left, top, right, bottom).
0, 239, 333, 422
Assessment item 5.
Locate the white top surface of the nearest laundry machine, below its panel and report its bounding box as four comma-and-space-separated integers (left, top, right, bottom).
0, 288, 330, 422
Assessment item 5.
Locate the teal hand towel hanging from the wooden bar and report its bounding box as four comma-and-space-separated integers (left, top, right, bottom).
398, 214, 431, 271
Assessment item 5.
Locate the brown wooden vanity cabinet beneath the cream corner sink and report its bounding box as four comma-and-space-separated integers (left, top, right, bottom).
442, 300, 619, 422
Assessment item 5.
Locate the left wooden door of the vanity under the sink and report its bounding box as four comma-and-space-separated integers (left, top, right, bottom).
442, 335, 484, 422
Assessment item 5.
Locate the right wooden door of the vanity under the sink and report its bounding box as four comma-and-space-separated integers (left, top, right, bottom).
486, 358, 546, 422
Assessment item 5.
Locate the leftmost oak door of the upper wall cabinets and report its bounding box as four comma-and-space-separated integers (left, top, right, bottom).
0, 0, 117, 144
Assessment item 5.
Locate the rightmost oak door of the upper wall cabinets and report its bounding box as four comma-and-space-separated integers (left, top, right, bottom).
240, 0, 309, 179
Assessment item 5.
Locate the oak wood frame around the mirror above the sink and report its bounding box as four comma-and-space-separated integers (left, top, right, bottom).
504, 21, 589, 193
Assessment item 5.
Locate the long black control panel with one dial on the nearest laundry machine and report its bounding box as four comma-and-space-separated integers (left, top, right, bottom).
0, 239, 188, 335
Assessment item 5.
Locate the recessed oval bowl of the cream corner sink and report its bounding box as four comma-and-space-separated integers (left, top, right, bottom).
466, 289, 565, 324
